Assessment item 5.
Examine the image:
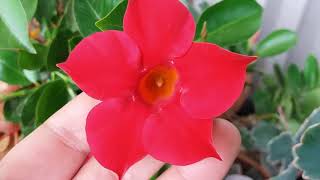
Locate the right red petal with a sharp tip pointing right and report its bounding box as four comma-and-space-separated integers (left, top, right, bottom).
176, 43, 256, 119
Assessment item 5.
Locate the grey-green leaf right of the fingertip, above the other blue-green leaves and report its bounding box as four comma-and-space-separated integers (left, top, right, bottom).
252, 121, 280, 151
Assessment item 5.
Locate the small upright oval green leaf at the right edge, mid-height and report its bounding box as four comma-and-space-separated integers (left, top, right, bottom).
303, 55, 319, 88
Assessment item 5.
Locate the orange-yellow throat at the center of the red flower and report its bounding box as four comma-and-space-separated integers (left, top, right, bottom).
138, 66, 178, 104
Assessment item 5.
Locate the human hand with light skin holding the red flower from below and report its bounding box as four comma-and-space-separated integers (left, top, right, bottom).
0, 93, 240, 180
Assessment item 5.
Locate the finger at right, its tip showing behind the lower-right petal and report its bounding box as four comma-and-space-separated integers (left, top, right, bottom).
159, 119, 241, 180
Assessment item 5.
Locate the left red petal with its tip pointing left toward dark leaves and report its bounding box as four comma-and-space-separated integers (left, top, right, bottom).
58, 31, 141, 100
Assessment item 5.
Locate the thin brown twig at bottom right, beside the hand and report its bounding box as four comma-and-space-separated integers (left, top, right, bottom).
237, 152, 271, 179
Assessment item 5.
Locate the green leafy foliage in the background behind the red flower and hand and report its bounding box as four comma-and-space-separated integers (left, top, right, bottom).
0, 0, 320, 180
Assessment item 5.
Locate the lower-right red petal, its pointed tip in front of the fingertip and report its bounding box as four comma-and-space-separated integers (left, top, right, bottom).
143, 97, 220, 165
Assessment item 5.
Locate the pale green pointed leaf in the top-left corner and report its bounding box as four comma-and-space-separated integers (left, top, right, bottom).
0, 0, 36, 54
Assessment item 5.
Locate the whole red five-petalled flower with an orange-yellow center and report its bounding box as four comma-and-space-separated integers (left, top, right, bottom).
59, 0, 255, 177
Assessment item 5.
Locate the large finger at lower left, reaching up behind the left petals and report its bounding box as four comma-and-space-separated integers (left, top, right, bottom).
0, 94, 98, 180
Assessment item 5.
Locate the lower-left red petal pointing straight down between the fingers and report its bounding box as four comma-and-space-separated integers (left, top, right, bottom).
86, 99, 149, 178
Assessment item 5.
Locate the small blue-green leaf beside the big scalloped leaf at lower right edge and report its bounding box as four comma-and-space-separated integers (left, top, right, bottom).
267, 132, 293, 163
